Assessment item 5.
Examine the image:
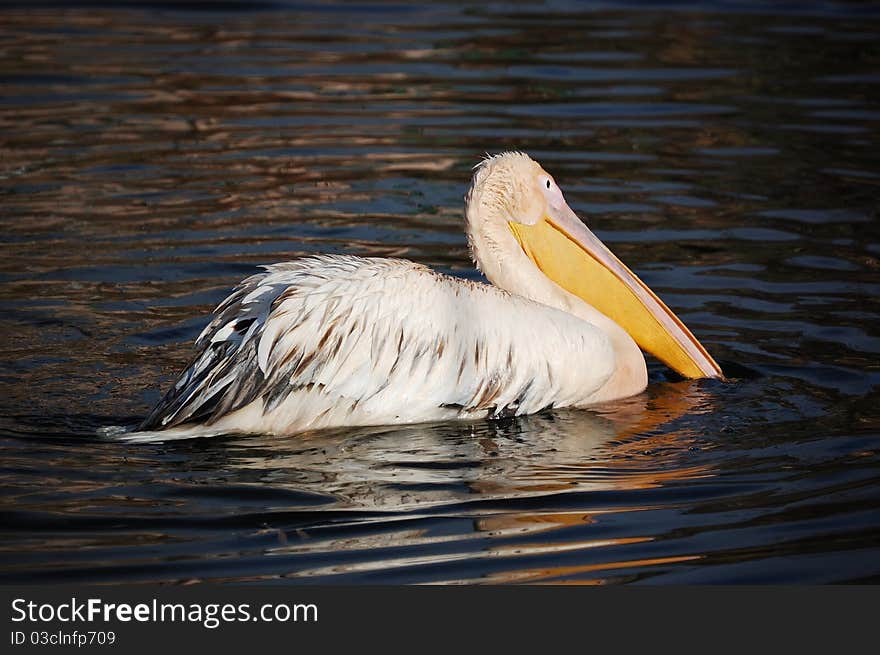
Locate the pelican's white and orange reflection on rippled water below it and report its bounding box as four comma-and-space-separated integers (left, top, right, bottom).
174, 381, 713, 582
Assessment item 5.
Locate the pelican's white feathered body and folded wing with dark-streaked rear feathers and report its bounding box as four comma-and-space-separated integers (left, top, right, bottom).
140, 256, 614, 432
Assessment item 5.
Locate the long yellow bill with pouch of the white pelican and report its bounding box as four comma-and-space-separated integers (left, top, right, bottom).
508, 201, 724, 378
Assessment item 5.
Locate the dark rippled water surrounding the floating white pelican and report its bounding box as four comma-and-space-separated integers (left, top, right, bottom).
0, 3, 880, 583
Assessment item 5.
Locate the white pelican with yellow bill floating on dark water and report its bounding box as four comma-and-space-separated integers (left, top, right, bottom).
139, 152, 723, 438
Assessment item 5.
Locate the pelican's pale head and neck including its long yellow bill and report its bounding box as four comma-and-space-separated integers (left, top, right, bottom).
466, 152, 723, 378
